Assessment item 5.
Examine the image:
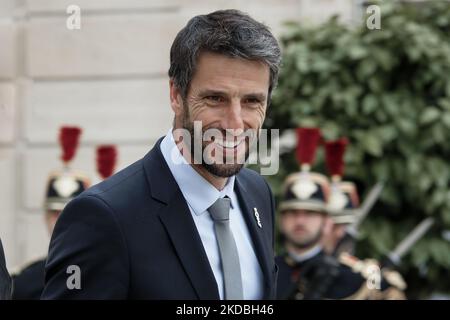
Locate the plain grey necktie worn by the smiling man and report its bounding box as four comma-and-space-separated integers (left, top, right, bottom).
208, 197, 244, 300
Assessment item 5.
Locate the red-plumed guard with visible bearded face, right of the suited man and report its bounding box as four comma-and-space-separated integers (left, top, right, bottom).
276, 128, 339, 300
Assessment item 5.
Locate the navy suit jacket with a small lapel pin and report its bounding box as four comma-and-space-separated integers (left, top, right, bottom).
42, 139, 278, 300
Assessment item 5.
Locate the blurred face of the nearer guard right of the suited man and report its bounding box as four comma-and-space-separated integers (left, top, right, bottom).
280, 210, 326, 249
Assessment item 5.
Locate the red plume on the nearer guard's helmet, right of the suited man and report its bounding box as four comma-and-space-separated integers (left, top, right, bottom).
297, 128, 320, 165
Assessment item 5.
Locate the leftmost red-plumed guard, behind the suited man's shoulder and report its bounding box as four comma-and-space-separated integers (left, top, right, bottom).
13, 127, 90, 300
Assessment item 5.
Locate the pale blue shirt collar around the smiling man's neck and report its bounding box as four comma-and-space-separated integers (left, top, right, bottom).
160, 129, 236, 216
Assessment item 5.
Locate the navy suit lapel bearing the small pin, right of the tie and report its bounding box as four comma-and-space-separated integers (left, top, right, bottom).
236, 175, 273, 299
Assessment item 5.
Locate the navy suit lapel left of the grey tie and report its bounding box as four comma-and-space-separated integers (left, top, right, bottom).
144, 139, 220, 300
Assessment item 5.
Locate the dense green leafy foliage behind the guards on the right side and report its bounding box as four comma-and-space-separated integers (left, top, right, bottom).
266, 1, 450, 297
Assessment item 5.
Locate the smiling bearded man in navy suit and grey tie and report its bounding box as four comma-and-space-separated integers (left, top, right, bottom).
42, 10, 280, 299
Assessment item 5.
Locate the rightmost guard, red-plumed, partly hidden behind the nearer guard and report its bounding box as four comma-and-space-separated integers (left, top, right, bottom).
323, 138, 406, 299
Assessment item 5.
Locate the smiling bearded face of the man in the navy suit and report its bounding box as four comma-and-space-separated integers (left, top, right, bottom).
171, 52, 270, 177
